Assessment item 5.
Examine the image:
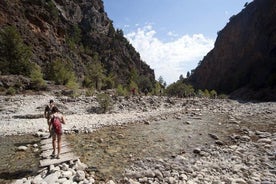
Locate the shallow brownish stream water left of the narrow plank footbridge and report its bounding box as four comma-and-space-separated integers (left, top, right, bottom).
0, 135, 40, 183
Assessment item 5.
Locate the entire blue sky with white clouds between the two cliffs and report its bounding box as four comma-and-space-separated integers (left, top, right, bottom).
103, 0, 252, 84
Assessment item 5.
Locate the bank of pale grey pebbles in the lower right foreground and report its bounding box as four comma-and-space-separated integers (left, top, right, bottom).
123, 129, 276, 184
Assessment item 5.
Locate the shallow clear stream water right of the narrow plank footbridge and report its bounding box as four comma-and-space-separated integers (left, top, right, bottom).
67, 114, 223, 181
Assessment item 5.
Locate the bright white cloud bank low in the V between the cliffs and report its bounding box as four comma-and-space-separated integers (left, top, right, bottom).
125, 25, 214, 84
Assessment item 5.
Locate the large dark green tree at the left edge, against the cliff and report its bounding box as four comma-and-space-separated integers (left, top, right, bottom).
0, 26, 32, 76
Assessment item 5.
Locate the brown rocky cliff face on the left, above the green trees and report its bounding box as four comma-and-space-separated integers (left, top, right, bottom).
0, 0, 154, 83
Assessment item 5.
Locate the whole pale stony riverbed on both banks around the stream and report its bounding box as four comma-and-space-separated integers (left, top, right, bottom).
0, 94, 276, 184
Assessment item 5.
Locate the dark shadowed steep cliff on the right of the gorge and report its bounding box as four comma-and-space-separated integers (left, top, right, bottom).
189, 0, 276, 100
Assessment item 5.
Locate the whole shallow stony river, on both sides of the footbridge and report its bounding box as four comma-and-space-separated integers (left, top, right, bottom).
0, 112, 231, 183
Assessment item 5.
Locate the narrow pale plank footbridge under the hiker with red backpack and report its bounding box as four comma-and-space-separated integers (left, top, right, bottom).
40, 137, 79, 167
